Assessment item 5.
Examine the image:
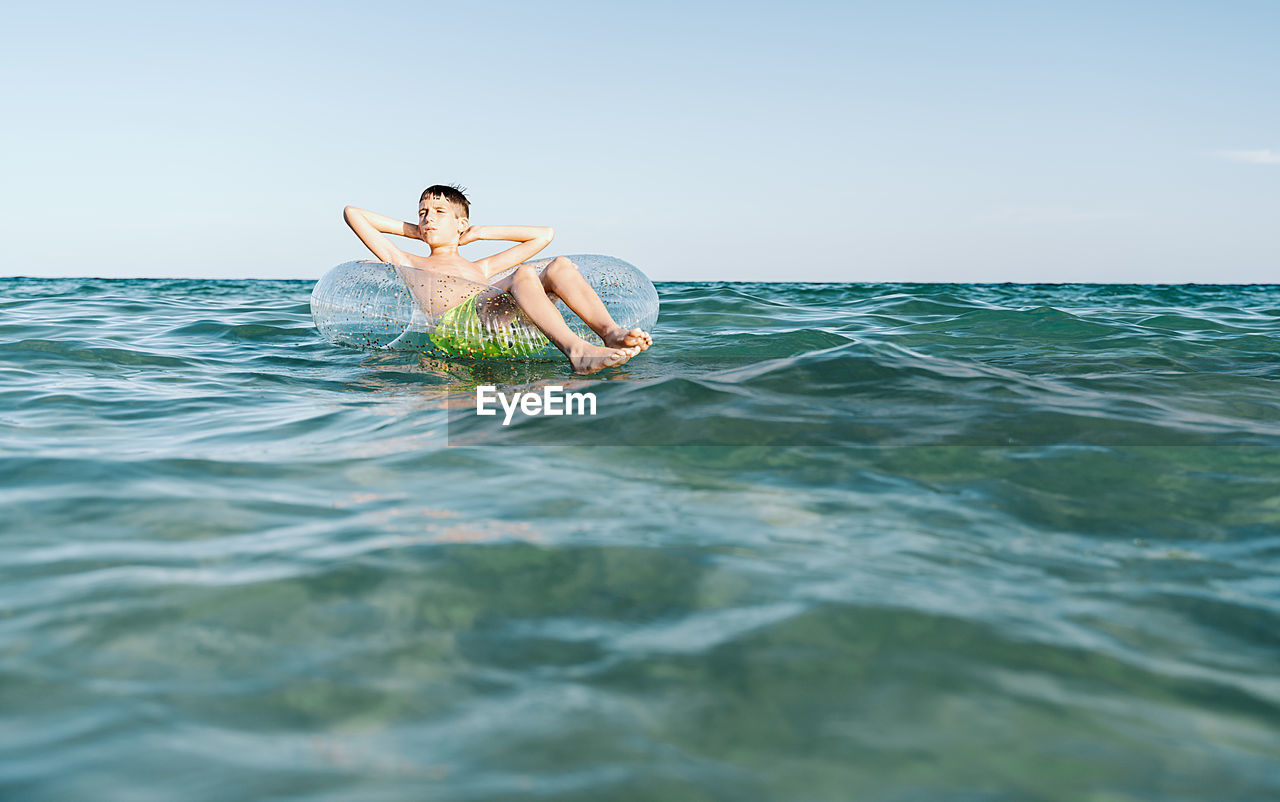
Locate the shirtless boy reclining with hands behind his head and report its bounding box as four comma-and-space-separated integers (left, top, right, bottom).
343, 184, 653, 373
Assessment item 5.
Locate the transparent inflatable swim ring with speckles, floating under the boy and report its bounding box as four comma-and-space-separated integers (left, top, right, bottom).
311, 255, 658, 361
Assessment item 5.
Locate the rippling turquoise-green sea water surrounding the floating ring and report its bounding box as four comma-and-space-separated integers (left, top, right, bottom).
0, 279, 1280, 802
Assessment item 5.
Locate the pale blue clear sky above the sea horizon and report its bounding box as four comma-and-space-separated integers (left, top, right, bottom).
0, 0, 1280, 283
